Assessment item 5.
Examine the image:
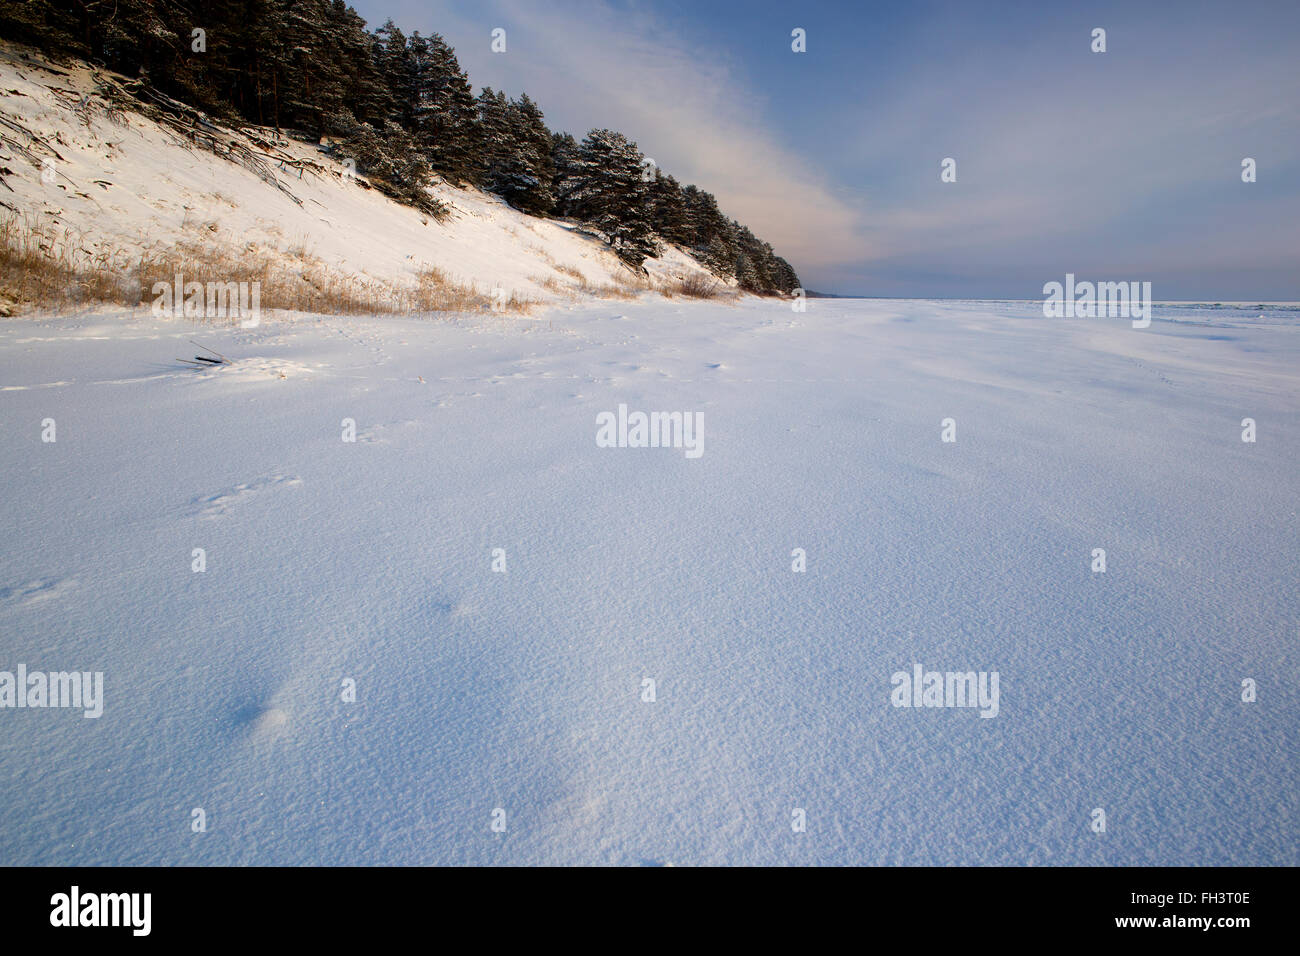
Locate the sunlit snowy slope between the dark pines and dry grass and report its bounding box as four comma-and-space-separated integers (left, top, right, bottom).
0, 44, 722, 310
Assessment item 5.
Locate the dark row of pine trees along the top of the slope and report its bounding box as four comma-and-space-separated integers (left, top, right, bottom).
0, 0, 798, 293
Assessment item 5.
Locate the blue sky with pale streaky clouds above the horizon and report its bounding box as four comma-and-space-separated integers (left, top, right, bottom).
352, 0, 1300, 300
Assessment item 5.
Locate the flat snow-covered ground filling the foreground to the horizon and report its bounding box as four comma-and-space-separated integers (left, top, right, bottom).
0, 297, 1300, 865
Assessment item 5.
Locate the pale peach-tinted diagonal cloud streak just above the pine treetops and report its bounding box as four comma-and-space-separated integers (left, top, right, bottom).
393, 0, 865, 269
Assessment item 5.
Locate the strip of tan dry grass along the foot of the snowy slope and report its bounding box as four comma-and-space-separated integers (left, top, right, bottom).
0, 217, 536, 315
